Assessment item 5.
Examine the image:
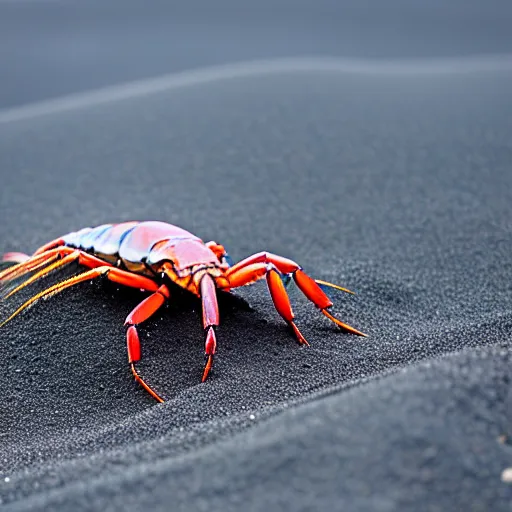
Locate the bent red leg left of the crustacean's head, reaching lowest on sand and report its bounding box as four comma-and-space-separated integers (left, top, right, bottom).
124, 285, 170, 402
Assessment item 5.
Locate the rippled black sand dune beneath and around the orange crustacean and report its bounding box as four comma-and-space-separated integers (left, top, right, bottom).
0, 67, 512, 511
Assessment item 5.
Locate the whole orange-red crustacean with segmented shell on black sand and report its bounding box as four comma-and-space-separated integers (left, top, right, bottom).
0, 221, 365, 402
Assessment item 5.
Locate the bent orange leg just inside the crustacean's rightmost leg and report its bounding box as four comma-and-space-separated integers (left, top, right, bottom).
223, 263, 309, 345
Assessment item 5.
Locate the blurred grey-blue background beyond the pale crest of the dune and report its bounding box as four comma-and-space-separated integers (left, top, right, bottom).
0, 0, 512, 109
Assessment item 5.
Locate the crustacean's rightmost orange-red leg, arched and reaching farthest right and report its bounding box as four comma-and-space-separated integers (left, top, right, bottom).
226, 252, 366, 336
